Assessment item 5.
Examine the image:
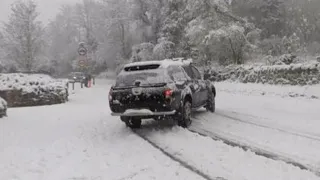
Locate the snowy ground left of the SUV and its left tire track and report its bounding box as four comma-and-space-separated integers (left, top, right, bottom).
0, 81, 201, 180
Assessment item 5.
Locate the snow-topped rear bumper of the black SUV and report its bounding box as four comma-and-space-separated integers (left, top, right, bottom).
111, 109, 176, 117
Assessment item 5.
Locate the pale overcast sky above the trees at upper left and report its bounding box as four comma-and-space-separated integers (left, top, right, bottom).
0, 0, 81, 24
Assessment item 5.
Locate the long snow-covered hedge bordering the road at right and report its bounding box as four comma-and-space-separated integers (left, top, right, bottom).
215, 63, 320, 85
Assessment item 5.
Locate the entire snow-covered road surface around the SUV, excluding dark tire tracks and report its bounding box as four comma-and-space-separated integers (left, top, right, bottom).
0, 81, 320, 180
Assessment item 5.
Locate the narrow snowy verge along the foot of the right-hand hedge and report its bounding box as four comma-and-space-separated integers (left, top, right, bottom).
214, 81, 320, 99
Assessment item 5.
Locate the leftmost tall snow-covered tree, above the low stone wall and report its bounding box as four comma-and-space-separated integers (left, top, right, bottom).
3, 0, 44, 71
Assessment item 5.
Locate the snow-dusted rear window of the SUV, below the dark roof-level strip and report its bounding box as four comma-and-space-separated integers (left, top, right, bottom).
115, 69, 170, 87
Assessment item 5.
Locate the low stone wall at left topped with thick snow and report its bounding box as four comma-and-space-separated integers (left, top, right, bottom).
0, 73, 68, 107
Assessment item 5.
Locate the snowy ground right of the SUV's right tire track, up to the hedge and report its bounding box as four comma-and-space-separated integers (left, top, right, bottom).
192, 83, 320, 172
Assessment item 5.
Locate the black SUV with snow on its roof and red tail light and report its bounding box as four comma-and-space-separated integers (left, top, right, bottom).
109, 60, 216, 128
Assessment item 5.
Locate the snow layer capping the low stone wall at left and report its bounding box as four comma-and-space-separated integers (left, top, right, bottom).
0, 73, 66, 93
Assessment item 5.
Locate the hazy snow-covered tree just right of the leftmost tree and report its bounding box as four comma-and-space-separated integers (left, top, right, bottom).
46, 5, 81, 75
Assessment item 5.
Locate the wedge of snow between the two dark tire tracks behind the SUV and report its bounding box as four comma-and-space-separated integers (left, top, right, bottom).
136, 125, 319, 180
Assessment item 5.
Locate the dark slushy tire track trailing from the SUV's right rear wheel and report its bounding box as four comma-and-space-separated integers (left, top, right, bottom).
188, 117, 320, 177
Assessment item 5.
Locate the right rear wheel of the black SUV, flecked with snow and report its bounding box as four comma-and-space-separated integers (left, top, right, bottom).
177, 100, 192, 128
